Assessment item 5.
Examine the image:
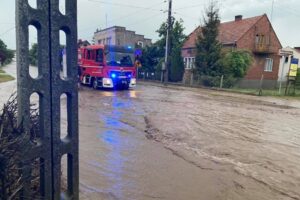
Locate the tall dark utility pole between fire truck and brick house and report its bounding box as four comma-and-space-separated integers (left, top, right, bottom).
163, 0, 172, 82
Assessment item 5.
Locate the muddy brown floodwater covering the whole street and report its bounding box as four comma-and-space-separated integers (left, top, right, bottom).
0, 62, 300, 200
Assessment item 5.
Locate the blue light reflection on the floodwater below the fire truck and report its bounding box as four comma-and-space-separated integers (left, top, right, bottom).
98, 91, 136, 198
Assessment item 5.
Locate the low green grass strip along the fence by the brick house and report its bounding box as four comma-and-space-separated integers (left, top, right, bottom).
228, 88, 300, 98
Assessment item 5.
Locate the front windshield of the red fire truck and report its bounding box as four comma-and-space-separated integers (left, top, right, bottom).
106, 52, 133, 67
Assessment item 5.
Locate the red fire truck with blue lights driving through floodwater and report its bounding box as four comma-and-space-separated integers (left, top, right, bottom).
78, 45, 139, 89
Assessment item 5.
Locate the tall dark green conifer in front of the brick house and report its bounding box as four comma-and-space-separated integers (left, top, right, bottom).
195, 1, 222, 76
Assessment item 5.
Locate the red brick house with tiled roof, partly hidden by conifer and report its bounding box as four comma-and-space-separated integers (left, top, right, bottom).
182, 14, 282, 88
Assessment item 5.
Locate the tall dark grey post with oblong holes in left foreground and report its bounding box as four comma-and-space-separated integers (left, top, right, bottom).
16, 0, 79, 199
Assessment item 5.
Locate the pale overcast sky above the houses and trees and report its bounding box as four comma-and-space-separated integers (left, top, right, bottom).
0, 0, 300, 49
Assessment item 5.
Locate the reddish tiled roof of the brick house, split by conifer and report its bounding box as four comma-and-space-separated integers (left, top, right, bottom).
183, 15, 265, 49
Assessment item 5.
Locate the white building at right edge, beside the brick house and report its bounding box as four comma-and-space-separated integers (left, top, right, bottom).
278, 47, 300, 82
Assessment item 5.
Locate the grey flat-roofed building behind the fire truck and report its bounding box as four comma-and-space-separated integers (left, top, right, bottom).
94, 26, 152, 47
